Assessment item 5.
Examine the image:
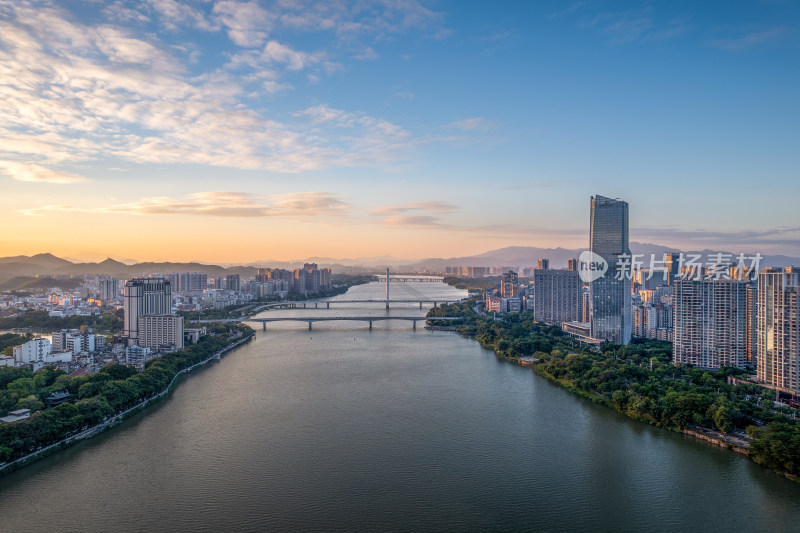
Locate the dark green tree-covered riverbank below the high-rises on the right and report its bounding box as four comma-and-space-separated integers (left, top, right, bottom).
429, 294, 800, 481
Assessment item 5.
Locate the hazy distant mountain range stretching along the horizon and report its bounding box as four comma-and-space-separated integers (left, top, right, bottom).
0, 242, 800, 289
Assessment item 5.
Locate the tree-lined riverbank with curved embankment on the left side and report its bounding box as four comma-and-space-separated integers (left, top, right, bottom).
0, 326, 255, 476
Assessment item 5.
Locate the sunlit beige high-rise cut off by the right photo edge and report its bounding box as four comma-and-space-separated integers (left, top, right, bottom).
756, 267, 800, 396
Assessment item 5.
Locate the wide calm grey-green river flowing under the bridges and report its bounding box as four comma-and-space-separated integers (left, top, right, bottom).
0, 283, 800, 531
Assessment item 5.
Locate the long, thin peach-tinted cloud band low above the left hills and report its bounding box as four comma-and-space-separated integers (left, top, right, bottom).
20, 191, 350, 218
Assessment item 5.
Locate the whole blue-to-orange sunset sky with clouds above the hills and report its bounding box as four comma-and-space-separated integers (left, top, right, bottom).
0, 0, 800, 263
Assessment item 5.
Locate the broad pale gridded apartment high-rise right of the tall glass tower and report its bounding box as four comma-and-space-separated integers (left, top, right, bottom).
672, 279, 747, 369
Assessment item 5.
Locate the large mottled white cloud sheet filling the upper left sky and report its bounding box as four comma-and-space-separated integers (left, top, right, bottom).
0, 2, 422, 176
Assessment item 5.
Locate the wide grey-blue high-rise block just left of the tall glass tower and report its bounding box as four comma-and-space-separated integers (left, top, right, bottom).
533, 266, 583, 324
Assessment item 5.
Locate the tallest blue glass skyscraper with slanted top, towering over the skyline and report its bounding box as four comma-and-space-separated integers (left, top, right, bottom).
589, 195, 631, 344
